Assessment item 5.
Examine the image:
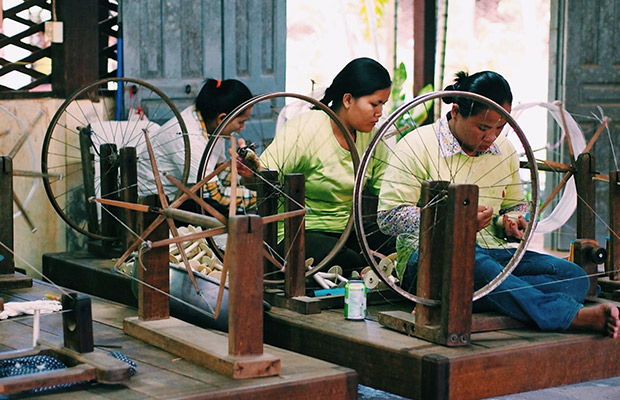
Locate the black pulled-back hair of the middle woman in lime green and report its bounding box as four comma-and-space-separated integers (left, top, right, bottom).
321, 57, 392, 111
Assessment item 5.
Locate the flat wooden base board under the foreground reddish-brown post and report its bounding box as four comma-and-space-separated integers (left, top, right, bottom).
123, 317, 280, 379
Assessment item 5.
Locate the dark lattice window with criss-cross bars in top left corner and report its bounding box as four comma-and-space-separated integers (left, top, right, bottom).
0, 0, 119, 98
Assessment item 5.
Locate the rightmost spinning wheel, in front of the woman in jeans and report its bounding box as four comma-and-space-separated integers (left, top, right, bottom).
353, 91, 538, 305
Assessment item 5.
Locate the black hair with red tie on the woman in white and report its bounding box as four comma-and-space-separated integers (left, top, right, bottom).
196, 78, 252, 122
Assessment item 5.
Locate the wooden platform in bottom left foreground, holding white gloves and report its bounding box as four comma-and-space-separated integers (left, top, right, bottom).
0, 281, 357, 400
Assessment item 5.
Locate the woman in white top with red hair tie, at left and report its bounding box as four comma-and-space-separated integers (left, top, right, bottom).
138, 79, 255, 212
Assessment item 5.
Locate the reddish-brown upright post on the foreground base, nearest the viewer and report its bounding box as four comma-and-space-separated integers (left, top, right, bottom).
222, 215, 263, 356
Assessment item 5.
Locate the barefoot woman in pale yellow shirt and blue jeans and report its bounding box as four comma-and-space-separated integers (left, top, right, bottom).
377, 71, 620, 337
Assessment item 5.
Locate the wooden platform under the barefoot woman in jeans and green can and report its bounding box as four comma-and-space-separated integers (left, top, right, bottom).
265, 306, 620, 400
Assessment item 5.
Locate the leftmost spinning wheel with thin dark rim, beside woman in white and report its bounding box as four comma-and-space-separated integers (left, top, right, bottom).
41, 78, 190, 241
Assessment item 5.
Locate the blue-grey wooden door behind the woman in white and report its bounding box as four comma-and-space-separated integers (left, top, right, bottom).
121, 0, 286, 109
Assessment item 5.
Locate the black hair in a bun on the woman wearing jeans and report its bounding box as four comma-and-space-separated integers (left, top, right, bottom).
442, 71, 512, 118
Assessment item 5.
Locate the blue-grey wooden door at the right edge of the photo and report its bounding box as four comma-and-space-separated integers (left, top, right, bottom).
549, 0, 620, 250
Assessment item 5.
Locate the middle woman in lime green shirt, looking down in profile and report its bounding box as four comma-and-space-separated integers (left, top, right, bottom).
260, 58, 392, 276
